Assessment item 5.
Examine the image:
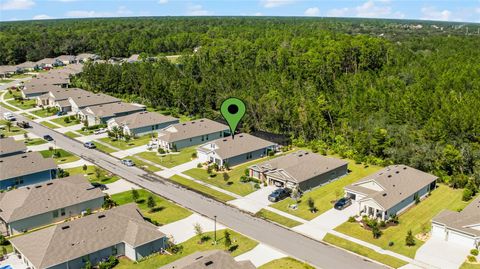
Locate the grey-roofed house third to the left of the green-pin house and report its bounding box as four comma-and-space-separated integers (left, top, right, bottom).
78, 102, 145, 126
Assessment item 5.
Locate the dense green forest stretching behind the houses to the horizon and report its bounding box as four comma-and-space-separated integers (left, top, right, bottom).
0, 18, 480, 191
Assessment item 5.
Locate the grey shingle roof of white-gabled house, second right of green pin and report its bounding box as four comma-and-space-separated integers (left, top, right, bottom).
345, 165, 438, 210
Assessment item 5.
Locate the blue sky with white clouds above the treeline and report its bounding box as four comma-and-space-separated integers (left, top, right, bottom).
0, 0, 480, 22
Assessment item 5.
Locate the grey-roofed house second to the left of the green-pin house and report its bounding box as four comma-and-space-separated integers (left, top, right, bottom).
107, 111, 178, 135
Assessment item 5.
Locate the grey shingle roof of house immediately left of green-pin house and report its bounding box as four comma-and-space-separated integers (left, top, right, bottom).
158, 119, 229, 143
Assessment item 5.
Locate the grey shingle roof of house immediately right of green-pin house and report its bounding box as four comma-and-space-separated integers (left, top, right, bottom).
251, 150, 348, 183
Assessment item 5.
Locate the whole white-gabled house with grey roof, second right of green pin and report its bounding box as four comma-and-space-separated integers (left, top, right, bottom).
345, 165, 438, 220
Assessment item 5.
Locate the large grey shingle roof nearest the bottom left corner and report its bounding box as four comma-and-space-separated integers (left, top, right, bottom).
10, 203, 165, 269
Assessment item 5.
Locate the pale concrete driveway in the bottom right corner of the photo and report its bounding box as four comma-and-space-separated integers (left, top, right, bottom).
415, 237, 470, 269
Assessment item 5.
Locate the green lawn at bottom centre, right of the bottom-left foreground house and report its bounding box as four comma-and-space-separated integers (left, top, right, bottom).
115, 227, 258, 269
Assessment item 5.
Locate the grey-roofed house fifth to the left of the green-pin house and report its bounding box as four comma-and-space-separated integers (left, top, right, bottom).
37, 87, 91, 112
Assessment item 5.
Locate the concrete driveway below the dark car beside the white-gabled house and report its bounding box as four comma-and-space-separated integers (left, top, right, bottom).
292, 206, 357, 240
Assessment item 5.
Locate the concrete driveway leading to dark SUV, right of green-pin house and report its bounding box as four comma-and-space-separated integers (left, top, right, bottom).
227, 186, 277, 214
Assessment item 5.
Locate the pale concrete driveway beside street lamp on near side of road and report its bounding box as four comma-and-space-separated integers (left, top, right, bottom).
158, 213, 225, 244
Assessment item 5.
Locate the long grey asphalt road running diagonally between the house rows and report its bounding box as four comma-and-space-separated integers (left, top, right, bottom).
0, 91, 386, 269
